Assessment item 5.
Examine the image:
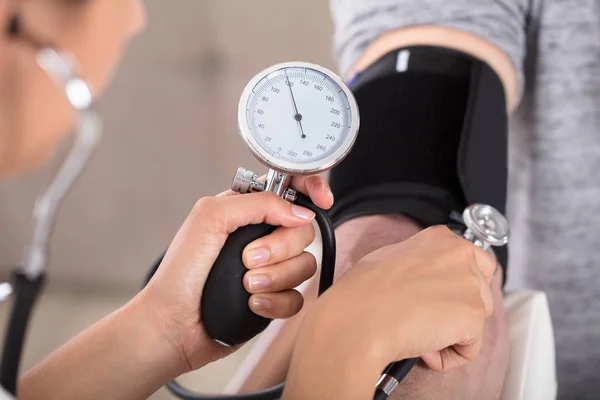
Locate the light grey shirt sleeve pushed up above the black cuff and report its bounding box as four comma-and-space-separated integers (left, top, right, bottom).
331, 0, 530, 98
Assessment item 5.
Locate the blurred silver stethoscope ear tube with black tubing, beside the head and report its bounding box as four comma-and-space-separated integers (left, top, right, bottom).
0, 48, 100, 395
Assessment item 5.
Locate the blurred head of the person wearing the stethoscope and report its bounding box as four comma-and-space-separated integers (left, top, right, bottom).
0, 0, 145, 179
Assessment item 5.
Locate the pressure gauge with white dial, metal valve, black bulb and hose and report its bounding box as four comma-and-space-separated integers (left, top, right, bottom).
201, 62, 359, 354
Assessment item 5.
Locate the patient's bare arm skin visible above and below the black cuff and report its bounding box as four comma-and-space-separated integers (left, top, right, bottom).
232, 26, 518, 399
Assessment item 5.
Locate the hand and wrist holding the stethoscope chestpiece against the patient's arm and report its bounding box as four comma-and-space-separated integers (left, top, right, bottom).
282, 227, 496, 400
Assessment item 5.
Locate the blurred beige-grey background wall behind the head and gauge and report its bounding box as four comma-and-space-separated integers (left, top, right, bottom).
0, 0, 335, 399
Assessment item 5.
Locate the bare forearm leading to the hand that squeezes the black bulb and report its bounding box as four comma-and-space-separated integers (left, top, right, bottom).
18, 290, 184, 400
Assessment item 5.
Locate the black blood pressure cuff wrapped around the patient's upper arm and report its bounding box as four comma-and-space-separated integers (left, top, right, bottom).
330, 46, 508, 279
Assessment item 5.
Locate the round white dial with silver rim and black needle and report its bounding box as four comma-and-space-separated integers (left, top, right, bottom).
240, 63, 358, 174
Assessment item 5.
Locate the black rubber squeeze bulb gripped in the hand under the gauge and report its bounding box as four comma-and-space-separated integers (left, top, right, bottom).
200, 224, 276, 346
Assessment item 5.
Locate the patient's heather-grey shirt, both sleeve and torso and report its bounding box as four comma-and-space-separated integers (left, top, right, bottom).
331, 0, 600, 399
